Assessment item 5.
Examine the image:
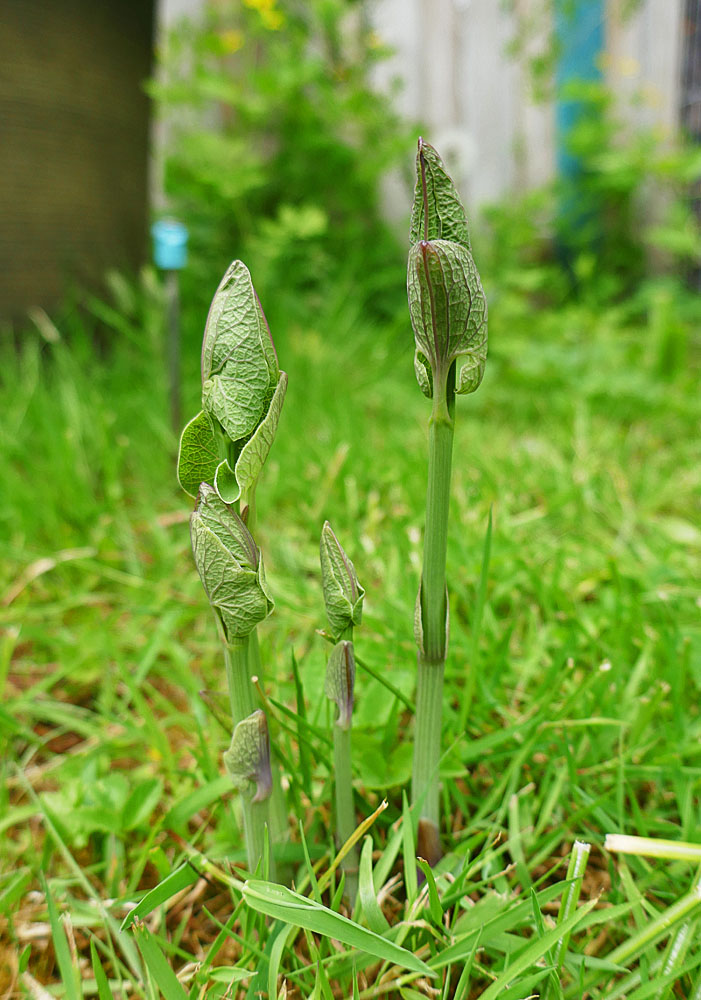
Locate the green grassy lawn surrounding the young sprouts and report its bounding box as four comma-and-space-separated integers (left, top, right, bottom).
0, 260, 701, 1000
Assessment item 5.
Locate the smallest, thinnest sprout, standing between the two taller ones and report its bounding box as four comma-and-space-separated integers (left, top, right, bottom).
320, 521, 365, 905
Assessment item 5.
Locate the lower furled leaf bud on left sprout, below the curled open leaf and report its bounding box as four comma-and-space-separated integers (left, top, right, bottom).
190, 483, 273, 642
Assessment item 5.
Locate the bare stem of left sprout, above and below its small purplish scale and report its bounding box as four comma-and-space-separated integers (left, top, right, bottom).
224, 636, 275, 879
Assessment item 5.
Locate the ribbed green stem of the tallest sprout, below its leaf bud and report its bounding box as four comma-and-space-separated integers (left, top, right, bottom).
411, 365, 455, 864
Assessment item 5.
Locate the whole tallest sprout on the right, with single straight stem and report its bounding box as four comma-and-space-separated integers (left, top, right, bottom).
407, 139, 487, 864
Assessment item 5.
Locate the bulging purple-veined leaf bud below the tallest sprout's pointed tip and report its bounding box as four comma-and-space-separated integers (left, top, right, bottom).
407, 240, 487, 395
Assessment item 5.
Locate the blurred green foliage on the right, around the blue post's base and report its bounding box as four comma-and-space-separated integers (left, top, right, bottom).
482, 82, 701, 316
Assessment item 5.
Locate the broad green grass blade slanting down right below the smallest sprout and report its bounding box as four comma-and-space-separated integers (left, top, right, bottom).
243, 879, 435, 976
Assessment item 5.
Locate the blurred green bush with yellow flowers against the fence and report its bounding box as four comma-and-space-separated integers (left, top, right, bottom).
151, 0, 413, 328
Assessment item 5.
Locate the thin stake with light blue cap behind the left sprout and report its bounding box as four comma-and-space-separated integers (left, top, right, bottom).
151, 219, 188, 434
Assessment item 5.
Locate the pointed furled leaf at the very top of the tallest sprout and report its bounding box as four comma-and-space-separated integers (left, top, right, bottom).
409, 139, 471, 251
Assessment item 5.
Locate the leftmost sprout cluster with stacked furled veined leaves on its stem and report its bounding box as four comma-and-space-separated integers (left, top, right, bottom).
178, 261, 287, 871
